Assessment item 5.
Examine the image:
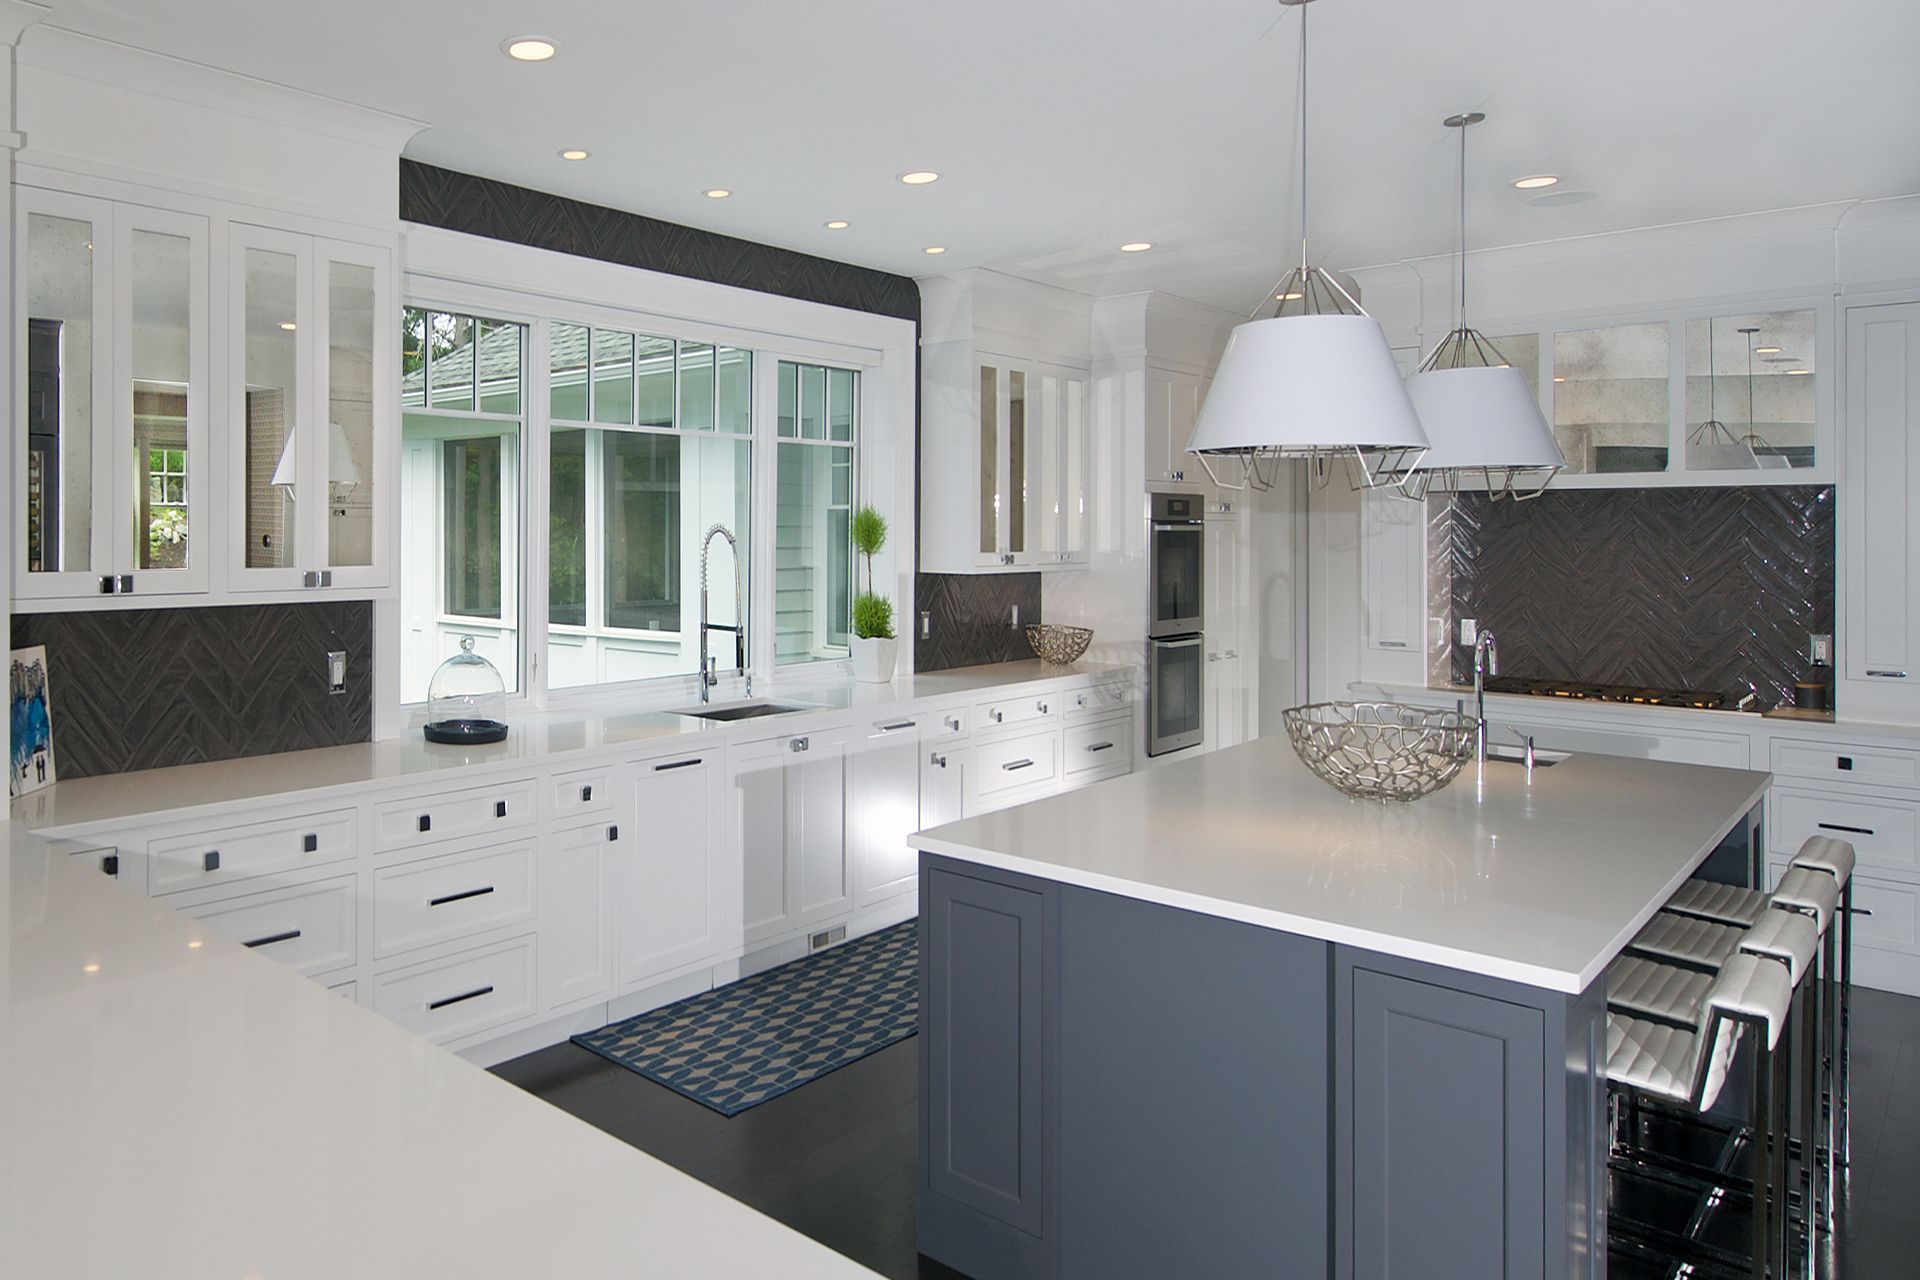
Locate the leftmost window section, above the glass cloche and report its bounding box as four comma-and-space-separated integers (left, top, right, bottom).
399, 309, 526, 702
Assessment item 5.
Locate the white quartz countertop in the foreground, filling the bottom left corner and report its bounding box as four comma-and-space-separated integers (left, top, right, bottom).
0, 825, 874, 1280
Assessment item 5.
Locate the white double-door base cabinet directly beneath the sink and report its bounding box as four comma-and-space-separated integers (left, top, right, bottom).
726, 727, 851, 946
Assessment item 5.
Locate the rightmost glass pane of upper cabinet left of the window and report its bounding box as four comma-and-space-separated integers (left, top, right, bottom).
326, 263, 376, 566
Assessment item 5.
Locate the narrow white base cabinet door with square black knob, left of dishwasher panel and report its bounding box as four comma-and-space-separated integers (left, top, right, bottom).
538, 821, 614, 1011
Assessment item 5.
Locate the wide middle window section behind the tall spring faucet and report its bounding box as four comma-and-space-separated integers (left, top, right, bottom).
547, 322, 753, 689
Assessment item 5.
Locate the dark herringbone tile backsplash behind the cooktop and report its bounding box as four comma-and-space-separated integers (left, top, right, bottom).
1428, 486, 1834, 706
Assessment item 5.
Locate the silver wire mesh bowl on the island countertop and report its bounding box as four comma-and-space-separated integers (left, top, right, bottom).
1281, 702, 1473, 800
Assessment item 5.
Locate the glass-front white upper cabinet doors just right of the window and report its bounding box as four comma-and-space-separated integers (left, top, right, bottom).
977, 363, 1089, 566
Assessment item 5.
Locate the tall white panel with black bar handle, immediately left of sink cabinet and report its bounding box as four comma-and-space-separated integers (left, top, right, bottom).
614, 743, 739, 990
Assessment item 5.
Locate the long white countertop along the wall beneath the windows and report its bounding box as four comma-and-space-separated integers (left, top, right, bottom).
13, 658, 1131, 833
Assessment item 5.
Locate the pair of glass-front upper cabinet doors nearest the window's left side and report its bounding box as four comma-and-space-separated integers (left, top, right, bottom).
228, 225, 399, 591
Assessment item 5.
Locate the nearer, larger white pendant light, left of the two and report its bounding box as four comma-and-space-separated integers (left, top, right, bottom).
1188, 0, 1427, 489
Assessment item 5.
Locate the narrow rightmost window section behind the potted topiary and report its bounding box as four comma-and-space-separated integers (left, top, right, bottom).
774, 361, 860, 662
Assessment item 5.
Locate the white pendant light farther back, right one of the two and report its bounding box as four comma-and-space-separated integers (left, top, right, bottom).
1400, 111, 1567, 501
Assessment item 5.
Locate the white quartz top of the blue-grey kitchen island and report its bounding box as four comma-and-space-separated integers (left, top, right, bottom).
912, 737, 1770, 992
